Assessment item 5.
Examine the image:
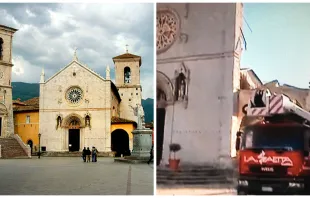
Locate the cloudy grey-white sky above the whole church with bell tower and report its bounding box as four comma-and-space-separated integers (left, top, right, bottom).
0, 3, 154, 99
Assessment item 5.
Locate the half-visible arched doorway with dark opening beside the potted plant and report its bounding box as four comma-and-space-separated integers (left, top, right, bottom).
156, 71, 173, 165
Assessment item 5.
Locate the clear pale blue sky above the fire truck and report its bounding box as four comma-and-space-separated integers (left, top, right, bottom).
241, 3, 310, 88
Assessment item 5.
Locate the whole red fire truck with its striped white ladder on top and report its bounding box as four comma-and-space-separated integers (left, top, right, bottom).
236, 90, 310, 195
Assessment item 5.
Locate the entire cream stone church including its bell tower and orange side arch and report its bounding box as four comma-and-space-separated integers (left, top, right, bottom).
39, 48, 144, 155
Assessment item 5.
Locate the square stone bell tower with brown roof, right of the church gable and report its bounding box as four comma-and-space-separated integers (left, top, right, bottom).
113, 49, 144, 123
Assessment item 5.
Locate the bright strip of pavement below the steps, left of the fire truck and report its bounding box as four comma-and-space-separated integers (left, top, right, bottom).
156, 186, 237, 196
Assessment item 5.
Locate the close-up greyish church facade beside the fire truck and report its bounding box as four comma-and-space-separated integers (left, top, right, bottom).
156, 3, 243, 167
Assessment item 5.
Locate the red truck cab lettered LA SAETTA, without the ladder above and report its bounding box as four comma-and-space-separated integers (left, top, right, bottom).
237, 120, 310, 194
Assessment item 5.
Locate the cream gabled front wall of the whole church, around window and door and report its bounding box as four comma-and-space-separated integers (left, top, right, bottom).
39, 61, 112, 151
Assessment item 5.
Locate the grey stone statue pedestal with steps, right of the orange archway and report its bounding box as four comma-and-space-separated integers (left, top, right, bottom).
114, 128, 153, 163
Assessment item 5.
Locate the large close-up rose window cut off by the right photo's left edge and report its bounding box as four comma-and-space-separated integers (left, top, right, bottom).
156, 9, 180, 53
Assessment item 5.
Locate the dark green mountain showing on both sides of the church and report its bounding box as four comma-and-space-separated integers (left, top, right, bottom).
12, 82, 154, 122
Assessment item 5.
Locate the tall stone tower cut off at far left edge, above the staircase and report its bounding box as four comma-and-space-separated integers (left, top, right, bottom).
0, 25, 17, 137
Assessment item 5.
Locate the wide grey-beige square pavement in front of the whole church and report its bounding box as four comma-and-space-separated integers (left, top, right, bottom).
0, 157, 154, 195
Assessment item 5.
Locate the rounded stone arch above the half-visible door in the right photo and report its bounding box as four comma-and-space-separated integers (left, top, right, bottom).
156, 71, 174, 107
